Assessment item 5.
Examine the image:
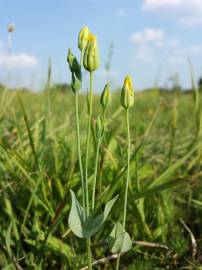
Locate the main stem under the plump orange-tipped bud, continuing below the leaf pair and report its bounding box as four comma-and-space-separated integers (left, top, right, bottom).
85, 72, 93, 270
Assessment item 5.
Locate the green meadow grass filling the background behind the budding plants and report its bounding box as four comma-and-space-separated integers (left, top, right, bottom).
0, 86, 202, 270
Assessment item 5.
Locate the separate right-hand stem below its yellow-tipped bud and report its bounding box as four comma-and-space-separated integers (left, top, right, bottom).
116, 108, 130, 270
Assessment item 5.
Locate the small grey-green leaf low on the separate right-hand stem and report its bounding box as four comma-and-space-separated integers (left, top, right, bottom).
108, 222, 132, 253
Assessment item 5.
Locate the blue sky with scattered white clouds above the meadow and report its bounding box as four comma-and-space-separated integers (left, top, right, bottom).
0, 0, 202, 91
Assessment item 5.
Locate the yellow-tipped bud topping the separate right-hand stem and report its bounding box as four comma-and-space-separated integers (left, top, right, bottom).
121, 76, 134, 109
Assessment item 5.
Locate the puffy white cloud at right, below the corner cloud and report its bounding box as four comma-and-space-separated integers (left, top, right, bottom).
131, 28, 202, 64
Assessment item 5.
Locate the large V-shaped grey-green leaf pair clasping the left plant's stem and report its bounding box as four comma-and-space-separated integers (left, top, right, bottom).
68, 190, 118, 238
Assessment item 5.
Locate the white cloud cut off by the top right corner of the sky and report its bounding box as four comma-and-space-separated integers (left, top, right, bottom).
142, 0, 202, 26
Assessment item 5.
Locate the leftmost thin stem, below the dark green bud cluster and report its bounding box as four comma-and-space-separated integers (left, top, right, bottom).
75, 92, 86, 212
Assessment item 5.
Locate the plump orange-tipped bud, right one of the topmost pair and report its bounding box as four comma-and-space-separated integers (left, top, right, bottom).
83, 34, 99, 72
